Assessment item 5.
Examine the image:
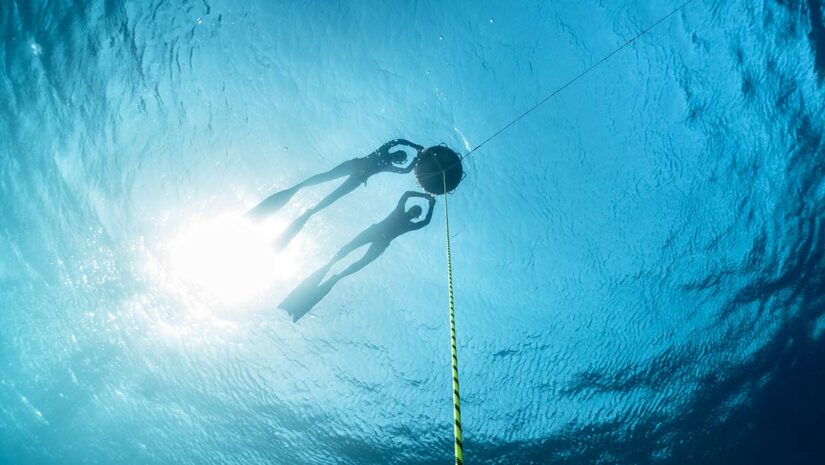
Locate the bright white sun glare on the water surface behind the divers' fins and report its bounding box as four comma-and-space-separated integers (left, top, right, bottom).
164, 211, 296, 304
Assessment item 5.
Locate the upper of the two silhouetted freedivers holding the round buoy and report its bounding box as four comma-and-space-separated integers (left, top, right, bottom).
247, 139, 424, 249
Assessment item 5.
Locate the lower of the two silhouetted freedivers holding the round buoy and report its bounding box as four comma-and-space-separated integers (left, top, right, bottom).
278, 191, 435, 321
